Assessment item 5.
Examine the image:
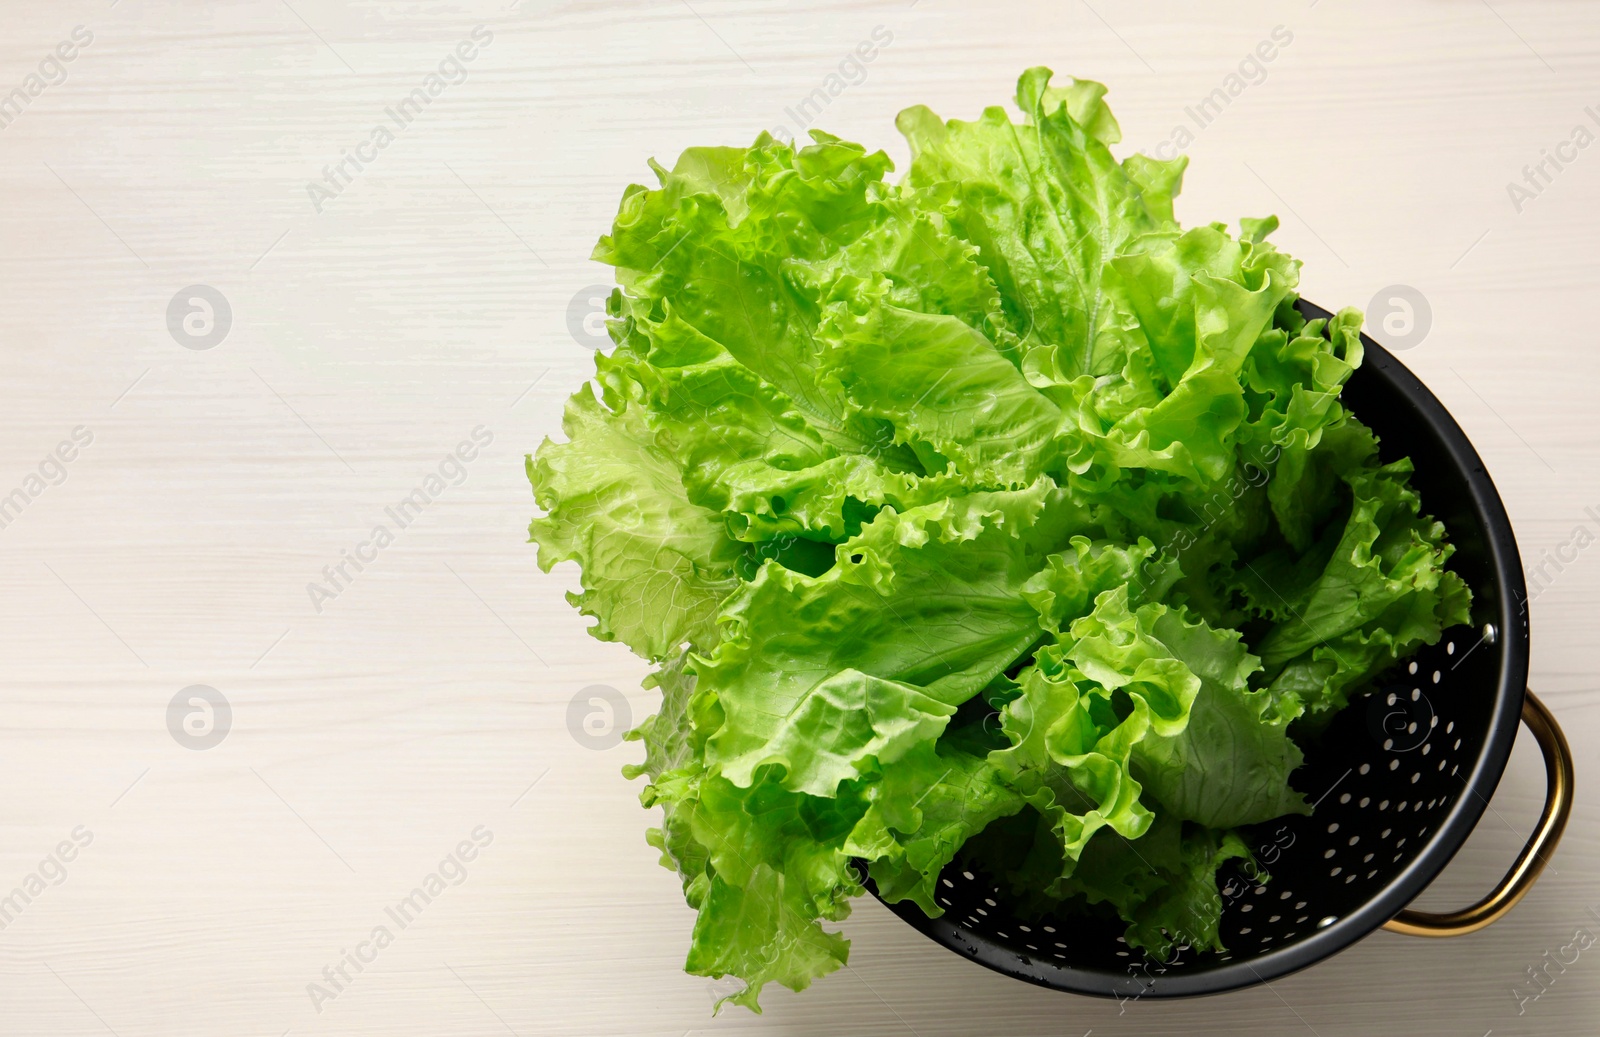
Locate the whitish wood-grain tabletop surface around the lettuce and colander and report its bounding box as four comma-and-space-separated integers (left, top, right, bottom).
0, 0, 1600, 1037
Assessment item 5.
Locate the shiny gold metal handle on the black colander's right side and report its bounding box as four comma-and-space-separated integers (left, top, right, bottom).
1384, 691, 1573, 936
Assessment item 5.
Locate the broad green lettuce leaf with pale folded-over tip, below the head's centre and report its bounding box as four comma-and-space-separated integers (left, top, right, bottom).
693, 482, 1074, 795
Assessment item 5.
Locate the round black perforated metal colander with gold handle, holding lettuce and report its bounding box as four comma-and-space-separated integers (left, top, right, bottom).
869, 301, 1573, 999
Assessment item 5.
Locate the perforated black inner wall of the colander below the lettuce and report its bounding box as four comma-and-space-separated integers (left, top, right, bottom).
876, 614, 1499, 992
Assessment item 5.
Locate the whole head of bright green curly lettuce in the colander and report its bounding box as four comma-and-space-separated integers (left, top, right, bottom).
528, 69, 1470, 1011
